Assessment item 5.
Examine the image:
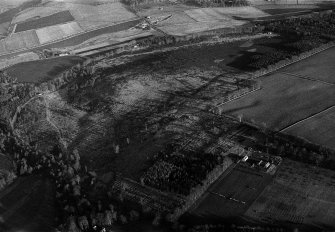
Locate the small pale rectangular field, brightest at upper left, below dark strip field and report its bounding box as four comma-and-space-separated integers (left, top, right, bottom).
36, 22, 83, 44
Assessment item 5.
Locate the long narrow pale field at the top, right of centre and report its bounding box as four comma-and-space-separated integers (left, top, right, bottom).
185, 6, 268, 22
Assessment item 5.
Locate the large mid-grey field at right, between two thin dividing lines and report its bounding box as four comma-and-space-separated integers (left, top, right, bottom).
222, 73, 335, 130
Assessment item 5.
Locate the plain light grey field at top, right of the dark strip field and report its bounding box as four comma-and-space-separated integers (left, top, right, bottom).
69, 3, 137, 30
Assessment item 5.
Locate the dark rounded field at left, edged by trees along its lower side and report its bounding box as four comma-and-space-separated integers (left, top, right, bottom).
7, 56, 83, 83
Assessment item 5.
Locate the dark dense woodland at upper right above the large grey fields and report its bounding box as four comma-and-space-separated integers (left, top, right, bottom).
248, 13, 335, 69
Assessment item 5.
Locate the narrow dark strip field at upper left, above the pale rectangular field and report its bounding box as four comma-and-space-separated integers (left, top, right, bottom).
15, 11, 74, 32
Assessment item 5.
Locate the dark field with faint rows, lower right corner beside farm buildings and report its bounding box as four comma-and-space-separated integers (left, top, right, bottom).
245, 160, 335, 231
